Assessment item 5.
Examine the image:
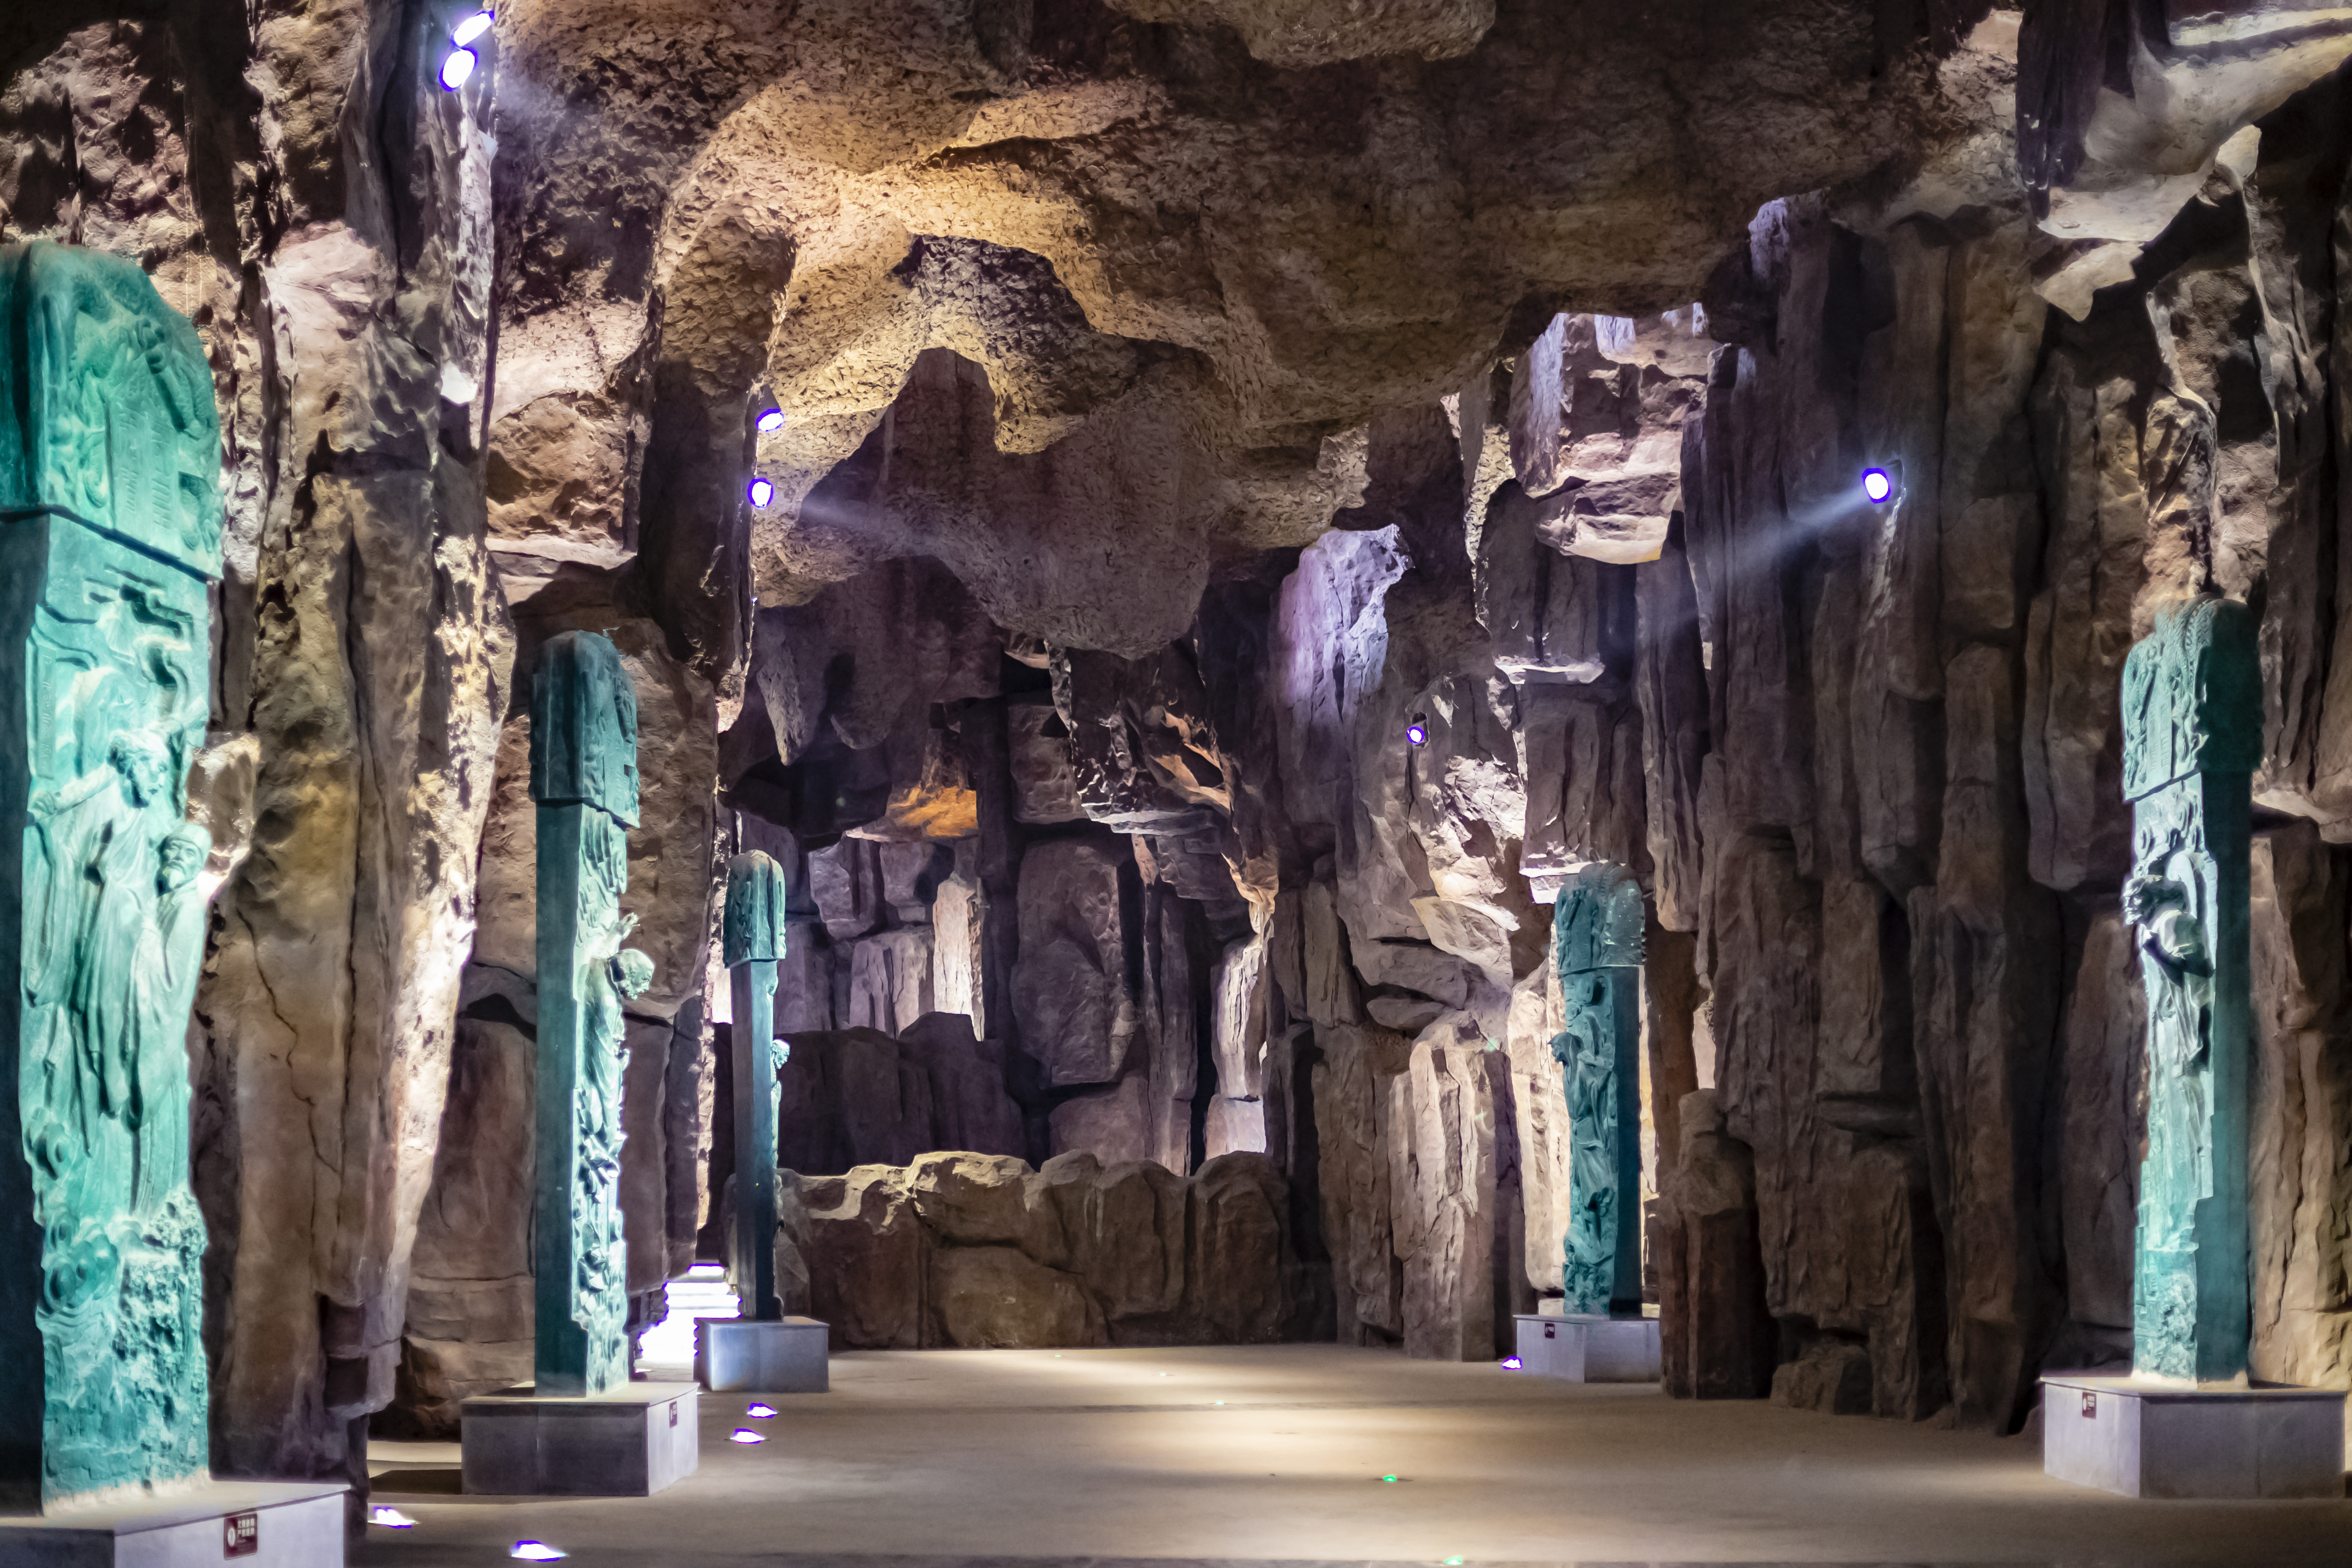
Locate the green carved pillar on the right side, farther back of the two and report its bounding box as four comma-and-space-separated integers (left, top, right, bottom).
1553, 863, 1642, 1314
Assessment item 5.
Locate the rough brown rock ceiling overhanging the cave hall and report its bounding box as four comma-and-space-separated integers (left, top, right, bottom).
494, 0, 2016, 653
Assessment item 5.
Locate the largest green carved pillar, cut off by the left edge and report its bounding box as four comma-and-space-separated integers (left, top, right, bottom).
0, 242, 221, 1504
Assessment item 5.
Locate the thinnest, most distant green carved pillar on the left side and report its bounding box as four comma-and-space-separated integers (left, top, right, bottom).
720, 848, 783, 1323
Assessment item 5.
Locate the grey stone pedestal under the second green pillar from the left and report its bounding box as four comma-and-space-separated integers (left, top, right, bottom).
459, 1382, 701, 1498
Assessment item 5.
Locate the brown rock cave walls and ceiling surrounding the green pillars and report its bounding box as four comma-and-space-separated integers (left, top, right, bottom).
0, 0, 2352, 1476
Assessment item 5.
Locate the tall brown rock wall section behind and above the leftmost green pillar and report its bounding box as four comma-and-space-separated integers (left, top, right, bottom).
0, 5, 513, 1476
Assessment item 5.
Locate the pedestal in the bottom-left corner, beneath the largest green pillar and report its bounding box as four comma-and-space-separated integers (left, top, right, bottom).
0, 1481, 350, 1568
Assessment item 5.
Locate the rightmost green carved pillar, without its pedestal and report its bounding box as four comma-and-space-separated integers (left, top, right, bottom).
2124, 600, 2263, 1382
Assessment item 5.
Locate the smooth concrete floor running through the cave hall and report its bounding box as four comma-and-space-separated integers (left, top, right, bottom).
353, 1344, 2352, 1568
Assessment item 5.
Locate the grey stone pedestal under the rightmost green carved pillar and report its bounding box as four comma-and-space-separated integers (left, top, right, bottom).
2042, 1375, 2345, 1498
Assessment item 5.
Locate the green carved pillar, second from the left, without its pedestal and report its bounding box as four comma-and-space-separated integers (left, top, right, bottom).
532, 632, 654, 1396
